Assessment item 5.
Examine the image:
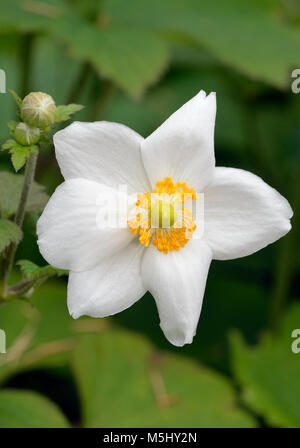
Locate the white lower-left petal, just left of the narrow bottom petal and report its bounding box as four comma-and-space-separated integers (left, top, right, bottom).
68, 240, 146, 319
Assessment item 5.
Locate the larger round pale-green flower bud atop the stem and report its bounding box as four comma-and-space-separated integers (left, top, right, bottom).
21, 92, 56, 129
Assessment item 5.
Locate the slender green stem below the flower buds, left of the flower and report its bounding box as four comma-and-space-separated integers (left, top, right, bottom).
4, 153, 38, 294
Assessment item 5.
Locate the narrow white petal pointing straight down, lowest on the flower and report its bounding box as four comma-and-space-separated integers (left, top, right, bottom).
142, 240, 212, 346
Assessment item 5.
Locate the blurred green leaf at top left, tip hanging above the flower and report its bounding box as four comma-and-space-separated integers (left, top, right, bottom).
0, 0, 168, 97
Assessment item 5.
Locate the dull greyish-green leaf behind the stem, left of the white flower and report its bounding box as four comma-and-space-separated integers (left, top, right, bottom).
0, 171, 48, 218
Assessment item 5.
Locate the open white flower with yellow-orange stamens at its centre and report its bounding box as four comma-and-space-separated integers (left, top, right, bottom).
37, 91, 292, 346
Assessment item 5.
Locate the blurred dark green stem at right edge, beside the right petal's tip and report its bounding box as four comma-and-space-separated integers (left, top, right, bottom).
269, 173, 300, 331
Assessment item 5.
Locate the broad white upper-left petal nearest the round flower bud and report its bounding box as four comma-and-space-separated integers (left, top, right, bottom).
54, 121, 149, 193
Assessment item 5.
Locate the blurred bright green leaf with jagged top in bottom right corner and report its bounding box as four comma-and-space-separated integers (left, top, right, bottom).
231, 305, 300, 428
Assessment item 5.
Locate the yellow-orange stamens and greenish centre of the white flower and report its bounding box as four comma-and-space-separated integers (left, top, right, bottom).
128, 177, 197, 253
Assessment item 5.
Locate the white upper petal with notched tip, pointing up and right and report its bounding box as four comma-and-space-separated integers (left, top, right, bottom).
142, 90, 216, 191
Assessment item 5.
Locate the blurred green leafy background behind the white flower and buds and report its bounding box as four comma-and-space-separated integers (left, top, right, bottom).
0, 0, 300, 427
